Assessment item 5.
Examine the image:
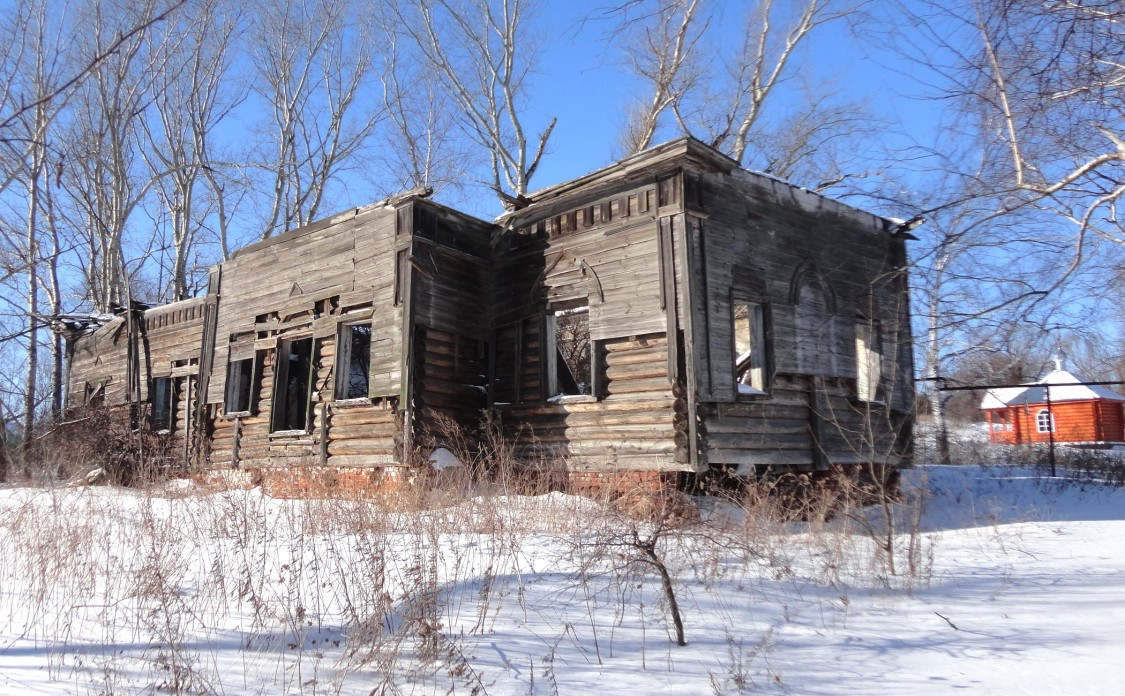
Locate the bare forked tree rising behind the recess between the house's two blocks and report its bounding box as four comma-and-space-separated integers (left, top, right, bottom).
398, 0, 557, 207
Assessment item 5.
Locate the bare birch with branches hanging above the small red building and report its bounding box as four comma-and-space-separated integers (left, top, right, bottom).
892, 0, 1125, 452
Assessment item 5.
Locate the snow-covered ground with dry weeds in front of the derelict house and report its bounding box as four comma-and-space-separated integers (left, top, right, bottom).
0, 467, 1125, 695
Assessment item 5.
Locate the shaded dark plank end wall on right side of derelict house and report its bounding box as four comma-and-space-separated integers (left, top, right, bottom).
681, 170, 914, 474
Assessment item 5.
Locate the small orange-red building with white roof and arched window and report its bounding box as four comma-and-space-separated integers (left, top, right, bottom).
981, 352, 1125, 444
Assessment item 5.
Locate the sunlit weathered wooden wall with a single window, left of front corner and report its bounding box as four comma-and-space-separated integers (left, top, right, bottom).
492, 179, 687, 471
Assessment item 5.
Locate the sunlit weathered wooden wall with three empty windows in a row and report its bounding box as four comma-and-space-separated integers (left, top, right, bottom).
207, 201, 413, 467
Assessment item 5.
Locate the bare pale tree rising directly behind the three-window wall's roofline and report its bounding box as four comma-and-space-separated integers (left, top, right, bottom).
250, 0, 383, 238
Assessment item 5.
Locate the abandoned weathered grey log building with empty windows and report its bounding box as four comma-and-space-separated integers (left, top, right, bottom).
69, 138, 914, 492
